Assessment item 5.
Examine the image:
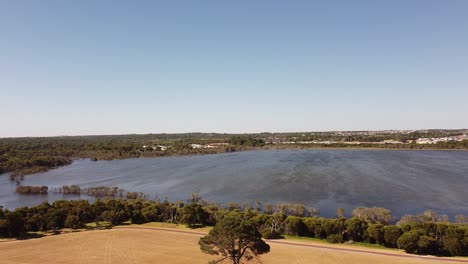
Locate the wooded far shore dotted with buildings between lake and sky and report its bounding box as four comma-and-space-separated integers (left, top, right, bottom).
0, 130, 468, 181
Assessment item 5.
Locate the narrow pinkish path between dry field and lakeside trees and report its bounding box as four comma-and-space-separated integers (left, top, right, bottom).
114, 226, 468, 263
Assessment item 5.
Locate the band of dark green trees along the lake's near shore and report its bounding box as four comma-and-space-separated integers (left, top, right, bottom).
0, 199, 468, 256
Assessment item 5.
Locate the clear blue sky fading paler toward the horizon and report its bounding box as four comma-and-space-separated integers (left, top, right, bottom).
0, 0, 468, 137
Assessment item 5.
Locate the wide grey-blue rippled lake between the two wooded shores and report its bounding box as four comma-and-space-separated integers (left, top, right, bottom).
0, 150, 468, 218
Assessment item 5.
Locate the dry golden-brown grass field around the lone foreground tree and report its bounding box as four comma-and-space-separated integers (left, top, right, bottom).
0, 224, 466, 264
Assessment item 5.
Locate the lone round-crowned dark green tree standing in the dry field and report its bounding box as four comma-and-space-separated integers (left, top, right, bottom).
198, 212, 270, 264
